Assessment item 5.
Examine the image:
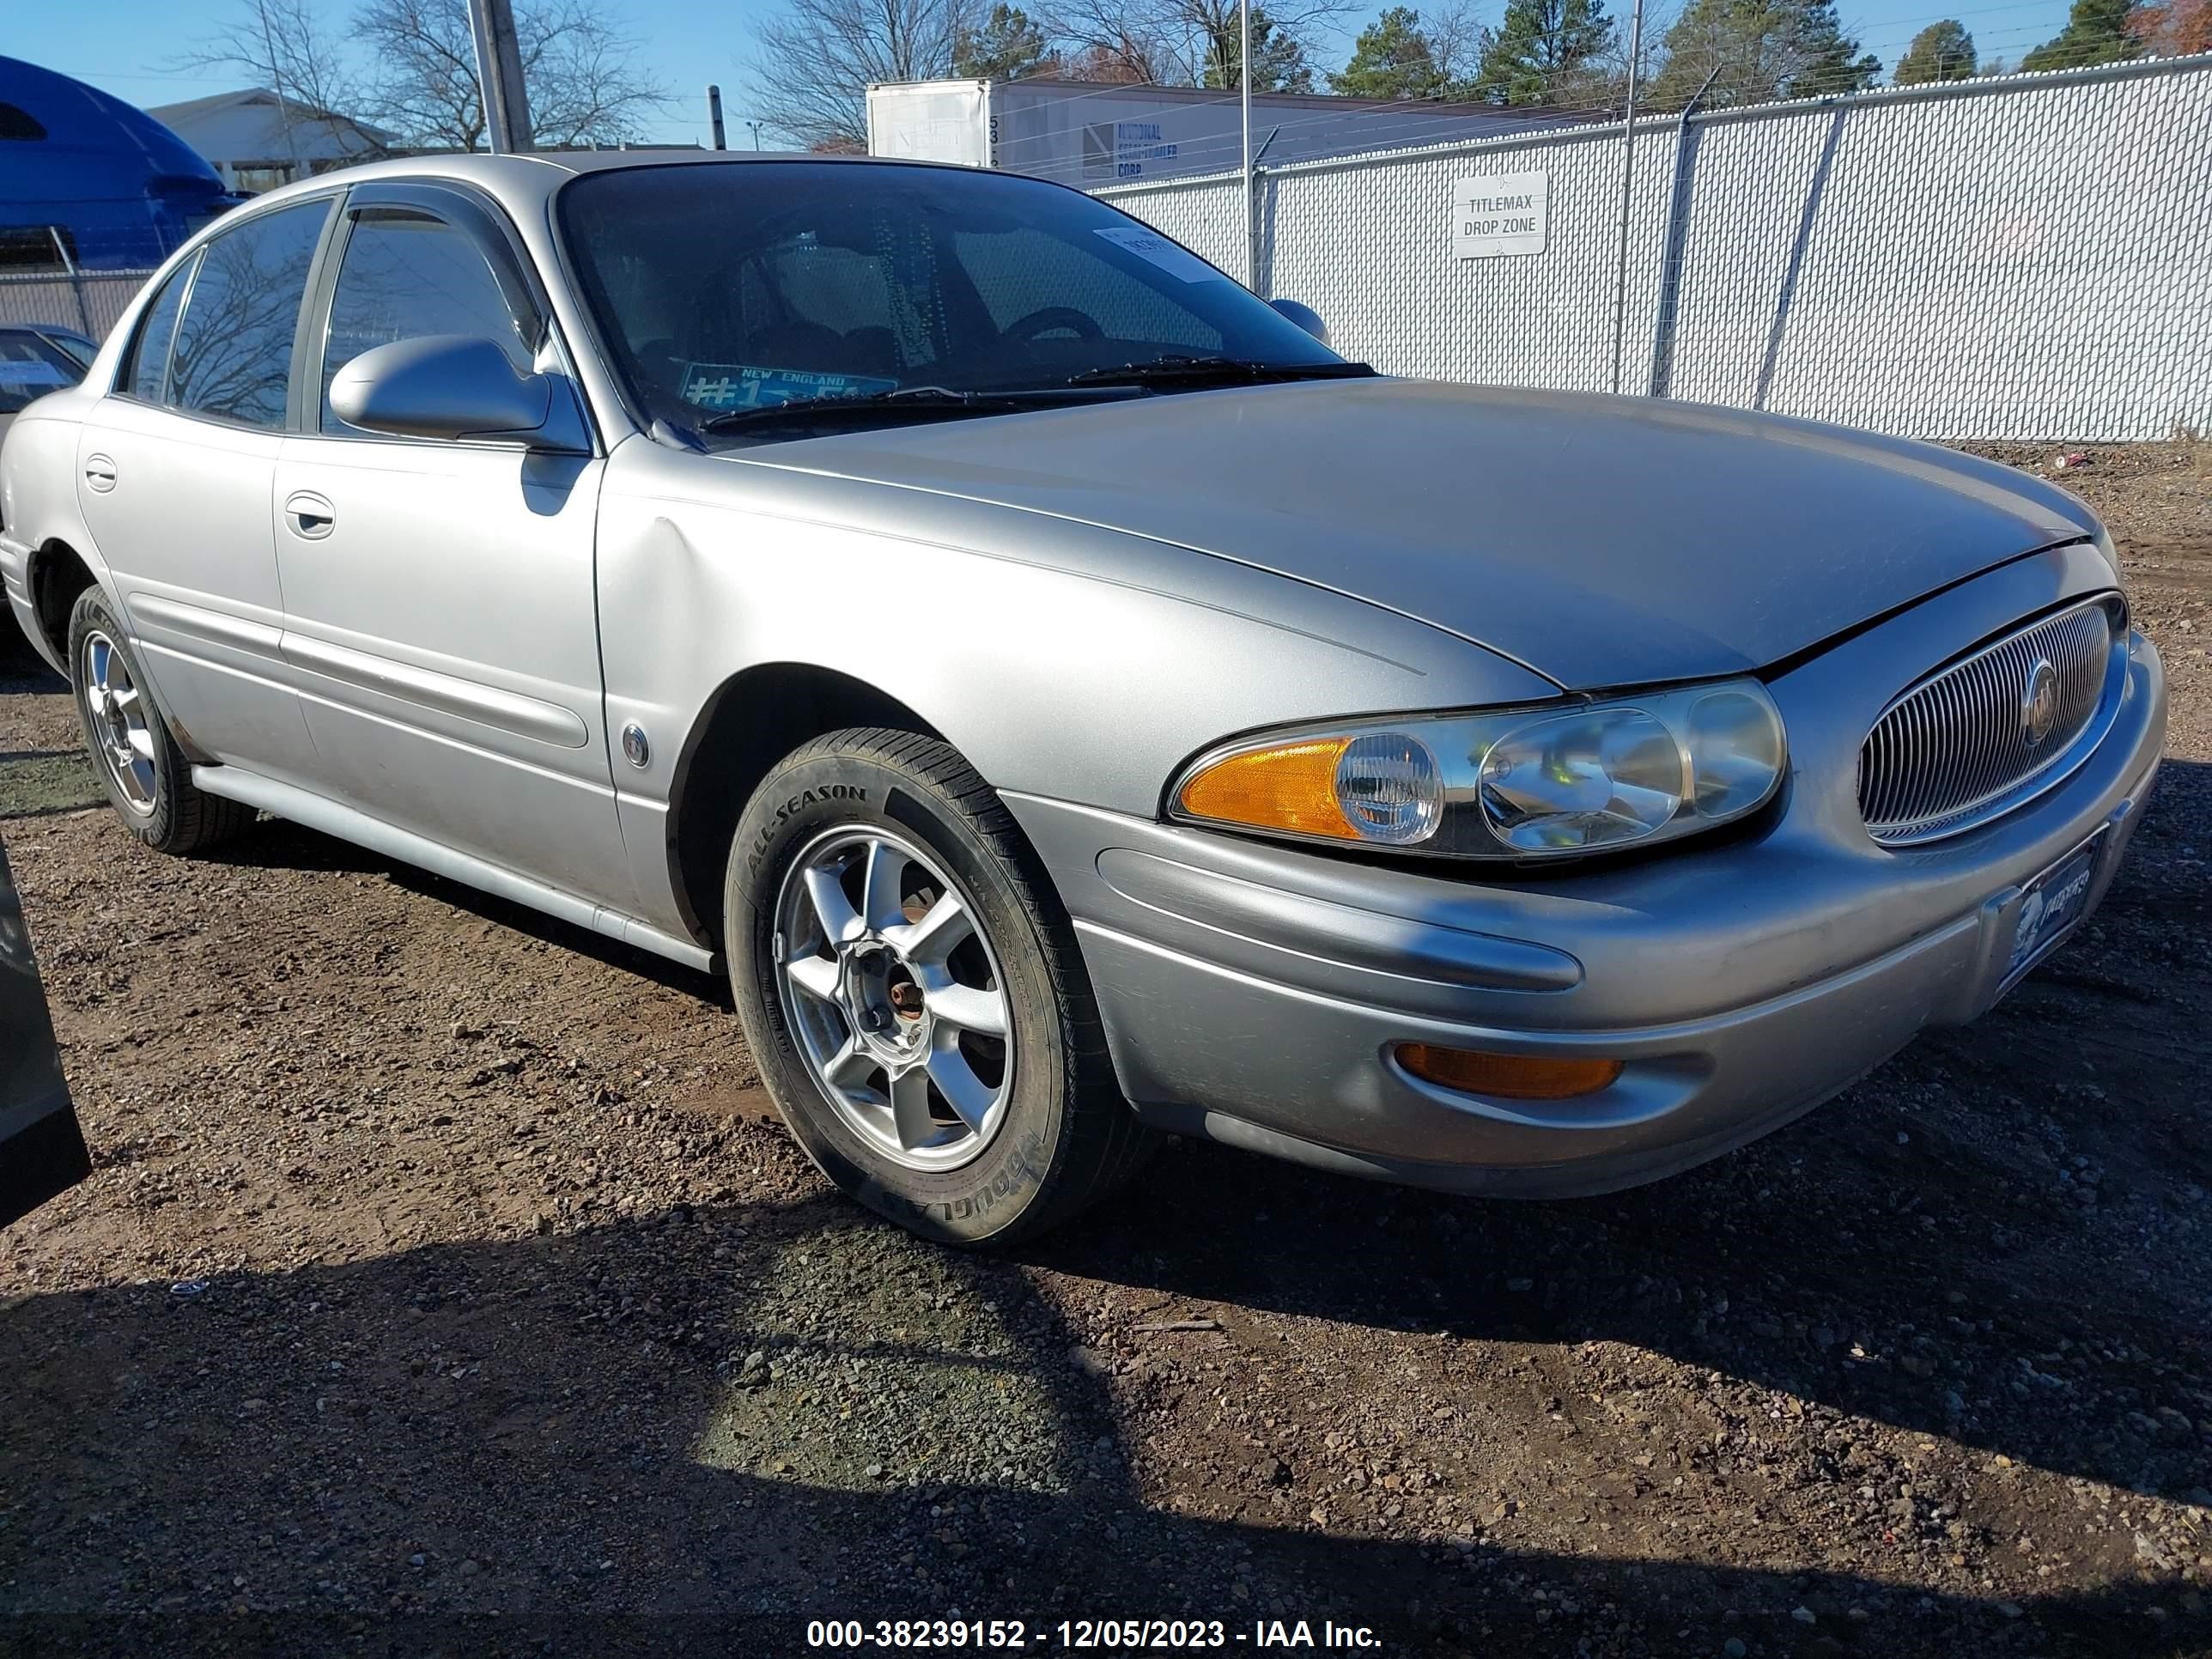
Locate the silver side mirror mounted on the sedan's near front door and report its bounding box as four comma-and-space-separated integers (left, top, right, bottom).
330, 334, 591, 453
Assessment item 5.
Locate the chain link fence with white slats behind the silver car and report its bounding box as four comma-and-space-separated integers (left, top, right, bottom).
1099, 58, 2212, 442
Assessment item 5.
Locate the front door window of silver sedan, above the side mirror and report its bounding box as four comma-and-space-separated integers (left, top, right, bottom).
321, 208, 540, 434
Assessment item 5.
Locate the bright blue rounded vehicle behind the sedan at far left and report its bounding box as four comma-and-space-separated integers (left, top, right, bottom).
0, 58, 241, 270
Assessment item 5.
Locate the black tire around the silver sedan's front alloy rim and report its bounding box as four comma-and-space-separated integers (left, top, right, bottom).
723, 730, 1159, 1248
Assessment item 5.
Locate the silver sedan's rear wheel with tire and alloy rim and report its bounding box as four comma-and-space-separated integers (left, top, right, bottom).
69, 588, 254, 854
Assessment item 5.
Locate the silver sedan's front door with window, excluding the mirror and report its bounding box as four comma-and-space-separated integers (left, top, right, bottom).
274, 185, 637, 914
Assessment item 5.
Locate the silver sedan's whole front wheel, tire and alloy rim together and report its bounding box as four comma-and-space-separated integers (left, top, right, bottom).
723, 730, 1155, 1245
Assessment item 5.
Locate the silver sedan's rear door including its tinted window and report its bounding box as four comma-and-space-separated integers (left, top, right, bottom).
77, 197, 337, 779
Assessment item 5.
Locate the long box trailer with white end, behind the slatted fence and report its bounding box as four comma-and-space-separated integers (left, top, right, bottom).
867, 76, 1582, 191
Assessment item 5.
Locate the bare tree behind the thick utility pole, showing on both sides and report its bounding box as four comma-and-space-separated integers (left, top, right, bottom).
354, 0, 668, 150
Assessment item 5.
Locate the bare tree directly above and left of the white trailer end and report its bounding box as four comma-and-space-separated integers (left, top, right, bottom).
748, 0, 980, 150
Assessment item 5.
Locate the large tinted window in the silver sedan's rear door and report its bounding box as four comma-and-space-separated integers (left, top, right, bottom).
168, 201, 330, 427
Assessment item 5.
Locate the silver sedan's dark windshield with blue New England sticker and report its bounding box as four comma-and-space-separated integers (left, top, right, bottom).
560, 161, 1338, 444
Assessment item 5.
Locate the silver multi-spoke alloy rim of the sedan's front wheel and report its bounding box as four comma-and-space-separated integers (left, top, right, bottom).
775, 825, 1015, 1170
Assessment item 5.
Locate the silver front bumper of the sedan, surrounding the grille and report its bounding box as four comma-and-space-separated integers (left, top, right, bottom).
1006, 549, 2166, 1197
